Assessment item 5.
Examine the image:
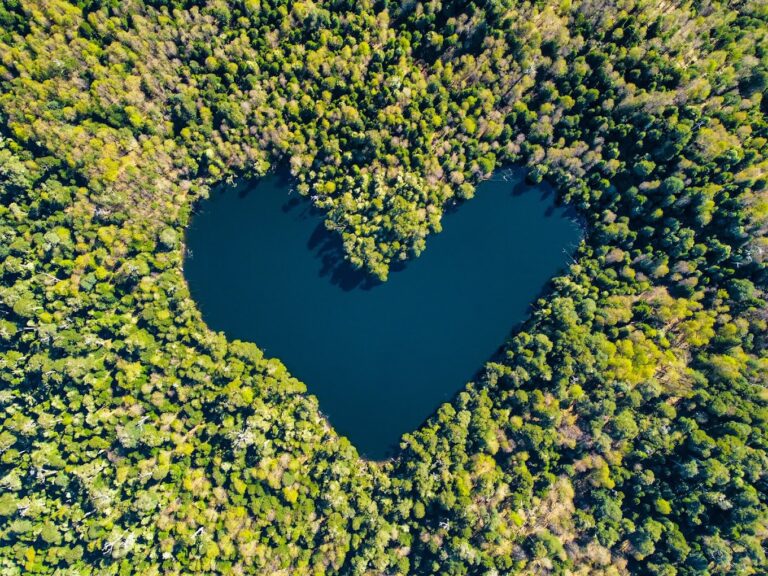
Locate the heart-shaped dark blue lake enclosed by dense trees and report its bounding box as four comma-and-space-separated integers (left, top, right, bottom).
184, 169, 580, 459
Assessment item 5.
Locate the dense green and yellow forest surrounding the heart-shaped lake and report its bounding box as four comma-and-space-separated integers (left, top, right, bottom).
0, 0, 768, 576
